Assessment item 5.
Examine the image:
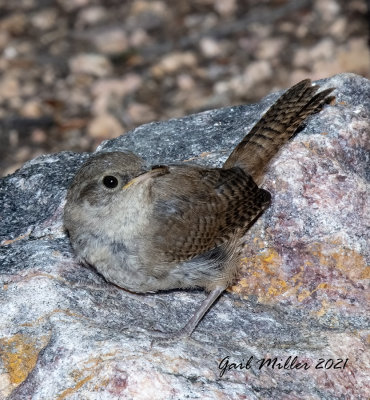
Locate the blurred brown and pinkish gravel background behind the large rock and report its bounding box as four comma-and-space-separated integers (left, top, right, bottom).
0, 0, 370, 176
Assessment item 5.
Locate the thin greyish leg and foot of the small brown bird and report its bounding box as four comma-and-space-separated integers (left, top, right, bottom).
152, 286, 225, 340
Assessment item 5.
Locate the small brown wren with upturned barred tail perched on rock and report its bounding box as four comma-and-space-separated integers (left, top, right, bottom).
64, 79, 333, 337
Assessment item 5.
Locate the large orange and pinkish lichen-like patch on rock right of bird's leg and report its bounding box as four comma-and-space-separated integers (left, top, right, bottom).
231, 242, 369, 317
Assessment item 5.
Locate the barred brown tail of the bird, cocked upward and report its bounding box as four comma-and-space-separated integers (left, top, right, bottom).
223, 79, 334, 184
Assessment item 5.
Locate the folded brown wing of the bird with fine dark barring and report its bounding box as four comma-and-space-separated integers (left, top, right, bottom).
150, 165, 270, 262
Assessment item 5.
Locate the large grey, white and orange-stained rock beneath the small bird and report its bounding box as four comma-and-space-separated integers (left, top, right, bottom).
0, 74, 370, 400
